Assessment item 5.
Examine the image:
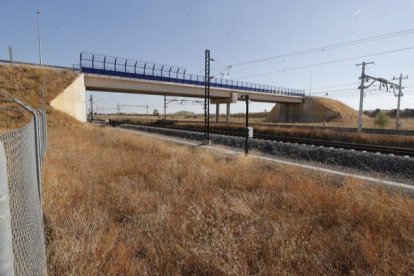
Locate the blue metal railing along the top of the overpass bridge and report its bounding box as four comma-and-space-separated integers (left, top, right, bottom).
79, 52, 305, 97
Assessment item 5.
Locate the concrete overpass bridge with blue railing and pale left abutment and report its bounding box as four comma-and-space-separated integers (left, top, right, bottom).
51, 52, 305, 122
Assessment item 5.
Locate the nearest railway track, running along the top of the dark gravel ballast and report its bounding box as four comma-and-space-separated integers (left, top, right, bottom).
109, 121, 414, 157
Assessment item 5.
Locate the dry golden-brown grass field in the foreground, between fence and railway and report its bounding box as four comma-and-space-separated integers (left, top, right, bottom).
2, 64, 414, 275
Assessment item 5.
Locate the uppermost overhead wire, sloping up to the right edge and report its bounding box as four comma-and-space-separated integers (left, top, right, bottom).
231, 28, 414, 67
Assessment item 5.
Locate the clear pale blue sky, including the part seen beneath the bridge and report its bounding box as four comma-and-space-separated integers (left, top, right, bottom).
0, 0, 414, 113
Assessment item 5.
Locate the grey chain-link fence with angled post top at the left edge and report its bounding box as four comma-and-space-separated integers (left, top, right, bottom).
0, 103, 47, 275
